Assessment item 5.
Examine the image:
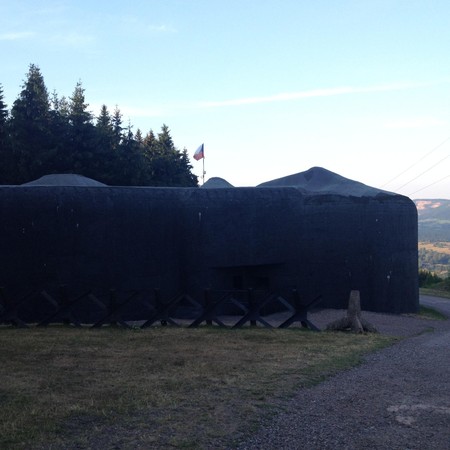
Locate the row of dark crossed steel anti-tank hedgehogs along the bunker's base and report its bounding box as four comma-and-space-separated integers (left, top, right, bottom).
0, 285, 321, 331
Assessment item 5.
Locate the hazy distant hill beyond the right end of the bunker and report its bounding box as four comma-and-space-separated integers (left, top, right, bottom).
414, 199, 450, 242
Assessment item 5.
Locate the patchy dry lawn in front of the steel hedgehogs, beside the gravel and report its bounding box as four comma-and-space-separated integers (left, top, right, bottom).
0, 327, 393, 449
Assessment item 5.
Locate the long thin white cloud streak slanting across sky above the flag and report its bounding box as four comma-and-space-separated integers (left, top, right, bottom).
197, 83, 446, 108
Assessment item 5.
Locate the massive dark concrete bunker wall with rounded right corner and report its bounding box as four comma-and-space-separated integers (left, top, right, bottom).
0, 169, 418, 313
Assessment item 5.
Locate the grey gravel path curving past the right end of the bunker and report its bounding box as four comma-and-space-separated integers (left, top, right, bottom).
238, 297, 450, 450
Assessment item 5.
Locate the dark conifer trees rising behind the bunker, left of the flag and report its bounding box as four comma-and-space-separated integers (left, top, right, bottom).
0, 64, 198, 187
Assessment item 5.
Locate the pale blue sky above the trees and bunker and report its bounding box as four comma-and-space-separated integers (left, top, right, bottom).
0, 0, 450, 199
